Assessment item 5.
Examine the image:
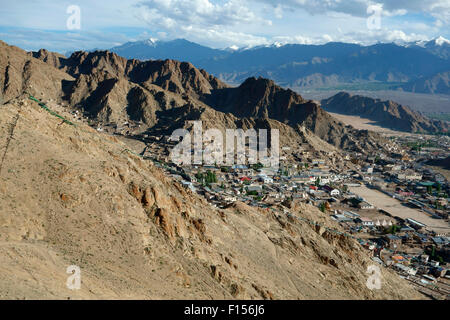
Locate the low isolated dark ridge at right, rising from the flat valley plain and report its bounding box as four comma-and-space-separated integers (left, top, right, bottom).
322, 92, 450, 133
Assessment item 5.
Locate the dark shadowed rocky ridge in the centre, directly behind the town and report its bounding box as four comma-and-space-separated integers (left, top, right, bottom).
204, 78, 390, 151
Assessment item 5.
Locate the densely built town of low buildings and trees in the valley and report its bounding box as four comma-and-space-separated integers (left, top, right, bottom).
139, 129, 450, 298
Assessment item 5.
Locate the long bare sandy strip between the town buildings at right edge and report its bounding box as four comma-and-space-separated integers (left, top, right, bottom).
350, 186, 450, 233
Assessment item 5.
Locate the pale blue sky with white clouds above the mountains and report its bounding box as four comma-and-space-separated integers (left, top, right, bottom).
0, 0, 450, 53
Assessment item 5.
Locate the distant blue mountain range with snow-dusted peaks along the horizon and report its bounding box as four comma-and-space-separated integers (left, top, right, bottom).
110, 37, 450, 94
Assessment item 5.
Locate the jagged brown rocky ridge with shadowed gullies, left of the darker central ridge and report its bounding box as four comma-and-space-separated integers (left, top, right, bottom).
35, 47, 230, 126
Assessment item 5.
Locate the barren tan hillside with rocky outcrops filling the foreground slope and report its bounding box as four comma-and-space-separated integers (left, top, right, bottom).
0, 96, 421, 299
